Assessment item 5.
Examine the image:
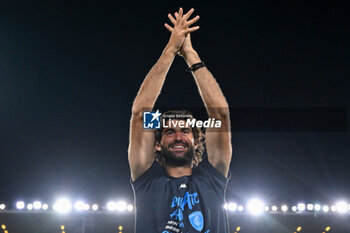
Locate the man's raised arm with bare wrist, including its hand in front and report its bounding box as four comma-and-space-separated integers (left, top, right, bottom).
128, 8, 199, 181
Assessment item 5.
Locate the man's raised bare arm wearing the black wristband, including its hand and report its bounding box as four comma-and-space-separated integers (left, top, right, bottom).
165, 13, 232, 177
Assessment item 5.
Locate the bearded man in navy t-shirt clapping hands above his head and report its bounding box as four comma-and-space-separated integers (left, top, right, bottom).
128, 8, 232, 233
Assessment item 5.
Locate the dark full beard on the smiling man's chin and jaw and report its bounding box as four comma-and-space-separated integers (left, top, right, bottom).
161, 145, 194, 167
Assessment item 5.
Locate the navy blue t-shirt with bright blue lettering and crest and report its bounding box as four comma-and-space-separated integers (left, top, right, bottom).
131, 157, 229, 233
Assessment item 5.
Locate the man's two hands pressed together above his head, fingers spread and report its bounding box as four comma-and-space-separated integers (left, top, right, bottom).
164, 8, 199, 56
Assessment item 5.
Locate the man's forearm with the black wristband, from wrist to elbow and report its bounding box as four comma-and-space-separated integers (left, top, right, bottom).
184, 49, 229, 117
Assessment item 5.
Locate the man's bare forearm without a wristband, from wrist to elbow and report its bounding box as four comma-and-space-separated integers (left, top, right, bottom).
132, 46, 176, 113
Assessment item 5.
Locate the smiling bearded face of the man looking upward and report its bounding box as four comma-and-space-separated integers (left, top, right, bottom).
156, 120, 197, 167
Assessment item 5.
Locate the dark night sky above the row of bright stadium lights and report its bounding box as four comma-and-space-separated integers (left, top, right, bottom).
0, 0, 350, 207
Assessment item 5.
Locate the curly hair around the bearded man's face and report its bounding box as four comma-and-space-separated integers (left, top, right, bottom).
154, 110, 205, 166
